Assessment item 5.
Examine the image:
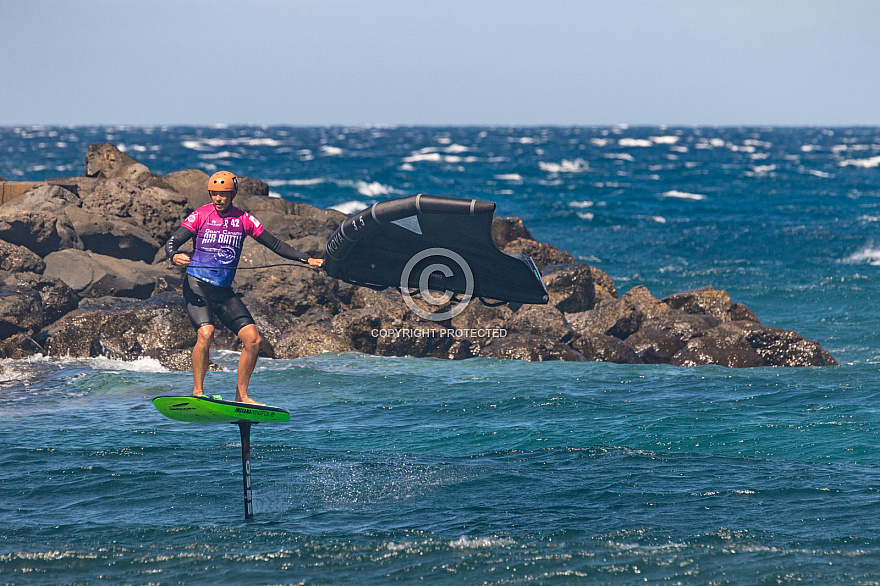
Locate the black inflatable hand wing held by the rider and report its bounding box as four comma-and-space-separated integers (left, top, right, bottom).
324, 195, 549, 304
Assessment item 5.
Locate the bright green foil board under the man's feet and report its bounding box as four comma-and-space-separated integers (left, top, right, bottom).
153, 395, 290, 423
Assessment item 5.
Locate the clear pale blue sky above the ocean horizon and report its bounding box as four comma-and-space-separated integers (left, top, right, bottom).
0, 0, 880, 126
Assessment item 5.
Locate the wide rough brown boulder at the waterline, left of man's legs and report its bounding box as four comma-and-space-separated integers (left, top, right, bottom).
45, 293, 196, 360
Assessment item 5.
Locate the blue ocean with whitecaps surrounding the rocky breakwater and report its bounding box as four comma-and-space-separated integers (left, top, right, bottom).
0, 126, 880, 585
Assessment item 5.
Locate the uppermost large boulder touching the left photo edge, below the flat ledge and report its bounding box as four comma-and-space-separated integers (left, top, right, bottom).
0, 206, 83, 257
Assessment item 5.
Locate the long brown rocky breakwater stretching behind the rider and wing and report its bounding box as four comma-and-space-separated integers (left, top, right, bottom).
0, 144, 836, 370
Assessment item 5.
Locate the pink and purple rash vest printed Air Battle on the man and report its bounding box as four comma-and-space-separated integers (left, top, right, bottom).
181, 204, 264, 287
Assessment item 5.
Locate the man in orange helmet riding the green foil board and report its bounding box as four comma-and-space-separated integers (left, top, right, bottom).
165, 171, 324, 405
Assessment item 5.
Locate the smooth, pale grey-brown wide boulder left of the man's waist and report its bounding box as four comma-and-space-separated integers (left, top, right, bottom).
43, 250, 168, 299
